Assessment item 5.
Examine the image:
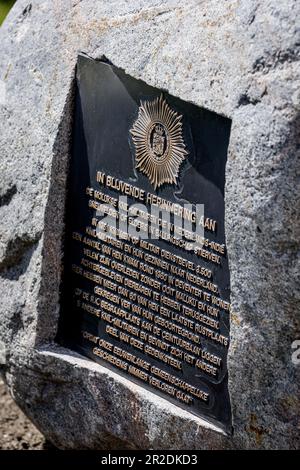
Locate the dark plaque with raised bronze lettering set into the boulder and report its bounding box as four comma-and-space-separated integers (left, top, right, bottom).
58, 55, 231, 433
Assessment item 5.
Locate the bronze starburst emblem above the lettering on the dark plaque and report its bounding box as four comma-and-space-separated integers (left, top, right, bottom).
130, 95, 188, 189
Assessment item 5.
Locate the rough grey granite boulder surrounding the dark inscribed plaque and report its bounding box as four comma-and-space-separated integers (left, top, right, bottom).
0, 0, 300, 449
